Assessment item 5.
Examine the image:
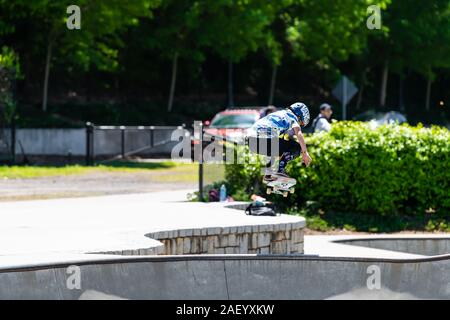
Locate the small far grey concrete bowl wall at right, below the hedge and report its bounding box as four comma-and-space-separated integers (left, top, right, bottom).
333, 237, 450, 256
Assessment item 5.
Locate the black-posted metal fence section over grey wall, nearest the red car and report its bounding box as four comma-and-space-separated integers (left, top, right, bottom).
86, 123, 186, 165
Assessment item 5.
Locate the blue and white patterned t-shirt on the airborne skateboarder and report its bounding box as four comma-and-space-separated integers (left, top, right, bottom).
248, 110, 300, 138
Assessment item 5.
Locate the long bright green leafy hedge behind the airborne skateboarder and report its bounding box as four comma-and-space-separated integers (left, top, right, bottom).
226, 122, 450, 214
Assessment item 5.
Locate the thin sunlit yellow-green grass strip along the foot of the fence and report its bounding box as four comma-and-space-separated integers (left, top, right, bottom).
0, 161, 183, 179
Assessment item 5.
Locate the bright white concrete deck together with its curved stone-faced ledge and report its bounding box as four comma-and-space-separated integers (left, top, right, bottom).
0, 191, 305, 256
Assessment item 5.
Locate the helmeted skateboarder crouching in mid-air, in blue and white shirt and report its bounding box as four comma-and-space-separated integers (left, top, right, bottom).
247, 102, 311, 184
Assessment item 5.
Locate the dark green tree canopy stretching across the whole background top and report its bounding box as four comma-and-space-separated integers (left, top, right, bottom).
0, 0, 450, 121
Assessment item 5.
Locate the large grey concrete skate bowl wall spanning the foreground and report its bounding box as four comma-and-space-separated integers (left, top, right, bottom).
0, 255, 450, 300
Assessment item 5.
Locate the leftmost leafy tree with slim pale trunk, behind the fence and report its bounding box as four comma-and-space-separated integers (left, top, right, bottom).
2, 0, 159, 111
